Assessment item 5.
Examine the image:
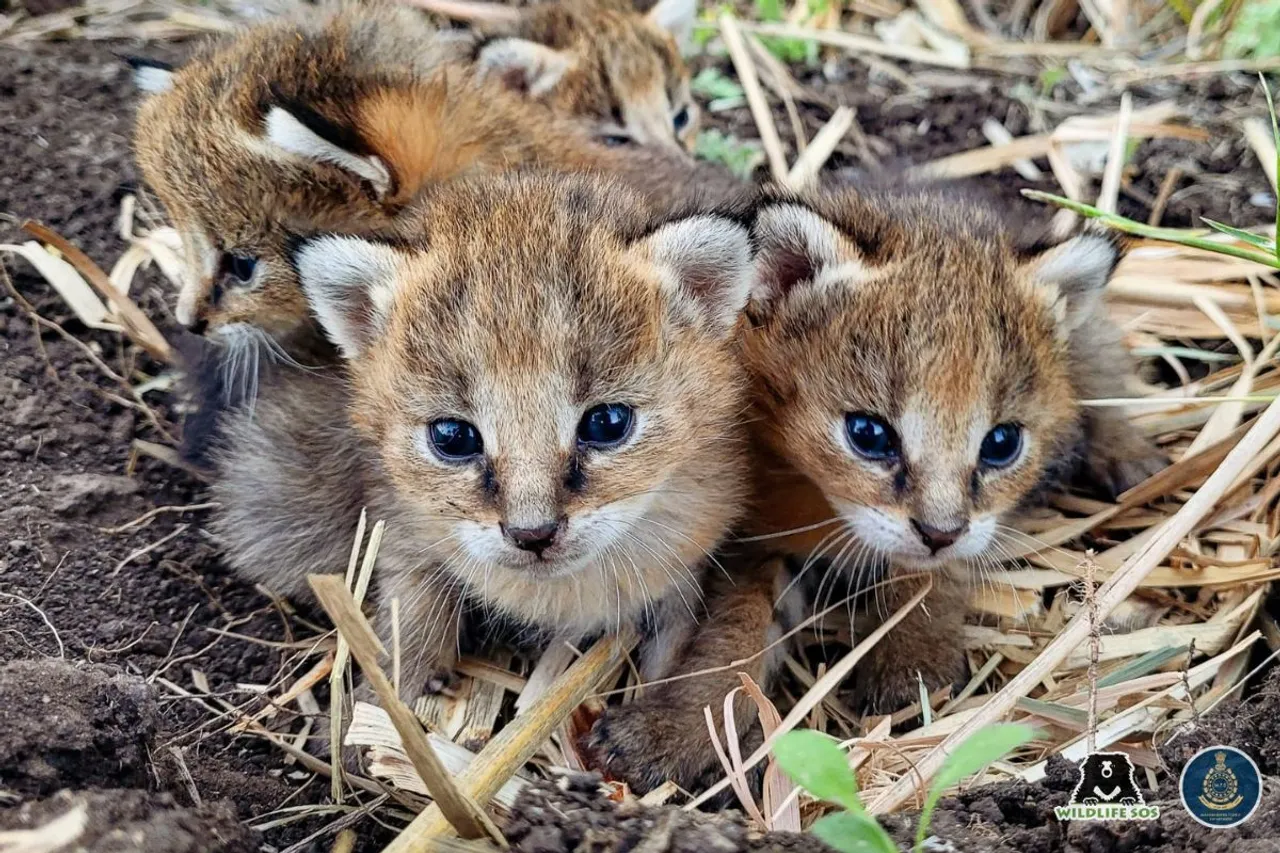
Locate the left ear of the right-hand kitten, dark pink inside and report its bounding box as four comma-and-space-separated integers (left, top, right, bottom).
751, 202, 868, 307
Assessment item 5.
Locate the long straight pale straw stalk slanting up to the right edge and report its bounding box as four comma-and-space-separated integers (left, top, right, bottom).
870, 398, 1280, 815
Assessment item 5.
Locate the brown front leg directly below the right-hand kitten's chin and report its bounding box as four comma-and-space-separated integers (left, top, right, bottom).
854, 571, 968, 713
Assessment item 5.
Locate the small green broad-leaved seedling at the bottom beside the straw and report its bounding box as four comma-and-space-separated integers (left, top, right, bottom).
773, 722, 1038, 853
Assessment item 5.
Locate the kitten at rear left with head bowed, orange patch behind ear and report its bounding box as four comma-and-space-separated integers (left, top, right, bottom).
134, 5, 737, 361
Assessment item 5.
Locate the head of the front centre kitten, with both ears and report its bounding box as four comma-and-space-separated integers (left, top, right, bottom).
298, 177, 749, 584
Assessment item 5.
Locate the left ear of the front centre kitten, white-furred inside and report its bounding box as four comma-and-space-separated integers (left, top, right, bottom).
292, 236, 402, 359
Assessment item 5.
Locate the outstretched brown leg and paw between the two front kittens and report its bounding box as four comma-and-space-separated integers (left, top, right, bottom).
586, 561, 780, 793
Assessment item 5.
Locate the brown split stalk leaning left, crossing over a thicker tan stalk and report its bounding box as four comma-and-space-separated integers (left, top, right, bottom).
307, 575, 507, 848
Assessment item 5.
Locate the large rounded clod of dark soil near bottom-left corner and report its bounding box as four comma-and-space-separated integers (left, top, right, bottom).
0, 661, 156, 797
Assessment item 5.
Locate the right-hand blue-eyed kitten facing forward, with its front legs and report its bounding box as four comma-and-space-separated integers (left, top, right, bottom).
594, 187, 1165, 790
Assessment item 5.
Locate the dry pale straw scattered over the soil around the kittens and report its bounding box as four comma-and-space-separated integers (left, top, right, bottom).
0, 0, 1280, 850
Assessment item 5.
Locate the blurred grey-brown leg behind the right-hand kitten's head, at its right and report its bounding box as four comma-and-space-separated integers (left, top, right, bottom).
1071, 315, 1169, 497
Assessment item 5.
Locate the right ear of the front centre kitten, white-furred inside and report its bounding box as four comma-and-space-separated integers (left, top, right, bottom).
631, 215, 751, 337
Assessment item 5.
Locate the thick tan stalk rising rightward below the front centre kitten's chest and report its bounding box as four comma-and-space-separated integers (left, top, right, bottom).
383, 634, 636, 853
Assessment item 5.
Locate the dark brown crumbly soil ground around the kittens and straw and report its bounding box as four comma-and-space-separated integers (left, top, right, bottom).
0, 23, 1280, 853
